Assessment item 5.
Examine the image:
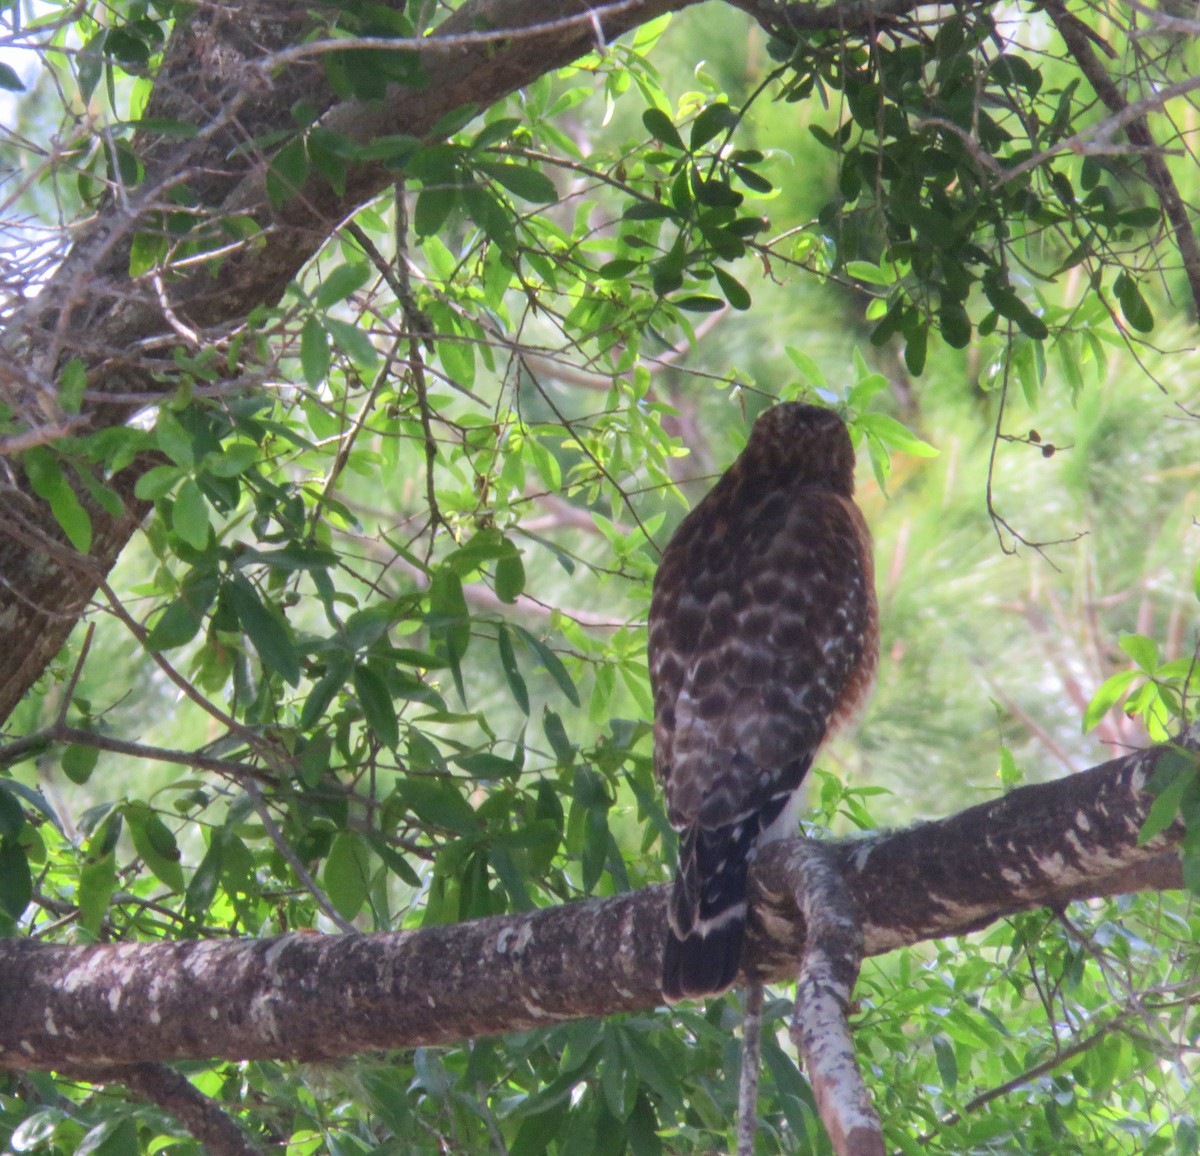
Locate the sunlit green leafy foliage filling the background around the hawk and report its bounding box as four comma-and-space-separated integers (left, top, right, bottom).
0, 4, 1200, 1156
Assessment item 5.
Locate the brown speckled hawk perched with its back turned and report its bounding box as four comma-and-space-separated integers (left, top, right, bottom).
649, 402, 878, 1001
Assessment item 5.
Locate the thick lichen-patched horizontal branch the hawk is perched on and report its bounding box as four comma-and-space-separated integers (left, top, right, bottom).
0, 734, 1181, 1068
